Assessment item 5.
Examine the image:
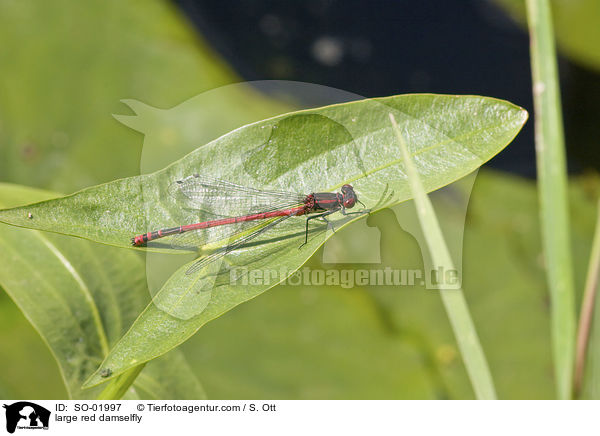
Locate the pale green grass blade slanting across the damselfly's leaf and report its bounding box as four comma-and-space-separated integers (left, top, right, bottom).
390, 114, 496, 400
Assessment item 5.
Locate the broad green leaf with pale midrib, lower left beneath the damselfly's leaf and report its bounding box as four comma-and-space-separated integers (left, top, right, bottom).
0, 184, 204, 398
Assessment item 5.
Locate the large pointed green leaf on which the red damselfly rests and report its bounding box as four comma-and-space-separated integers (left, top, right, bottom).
0, 94, 527, 384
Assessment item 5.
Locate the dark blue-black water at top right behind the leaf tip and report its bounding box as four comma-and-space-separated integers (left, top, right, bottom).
175, 0, 600, 177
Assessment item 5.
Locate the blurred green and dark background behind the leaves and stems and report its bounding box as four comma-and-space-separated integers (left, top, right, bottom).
0, 0, 600, 399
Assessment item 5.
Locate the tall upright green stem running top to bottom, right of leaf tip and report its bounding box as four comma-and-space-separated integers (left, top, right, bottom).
527, 0, 575, 399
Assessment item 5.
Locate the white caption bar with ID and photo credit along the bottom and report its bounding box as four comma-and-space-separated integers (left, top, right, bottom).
0, 400, 599, 436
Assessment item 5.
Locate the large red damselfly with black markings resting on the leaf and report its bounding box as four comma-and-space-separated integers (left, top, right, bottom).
131, 174, 368, 274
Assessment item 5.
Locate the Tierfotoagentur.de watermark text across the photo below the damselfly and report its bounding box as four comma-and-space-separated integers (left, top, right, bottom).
229, 267, 461, 289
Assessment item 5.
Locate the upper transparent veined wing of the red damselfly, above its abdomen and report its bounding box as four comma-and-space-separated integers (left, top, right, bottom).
169, 174, 305, 217
